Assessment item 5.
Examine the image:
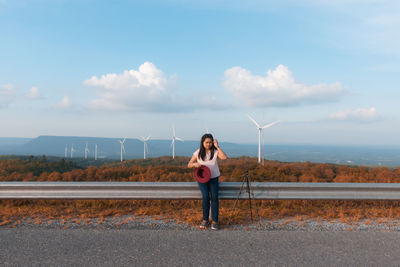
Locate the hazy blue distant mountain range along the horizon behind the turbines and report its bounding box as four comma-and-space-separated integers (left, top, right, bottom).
0, 136, 400, 167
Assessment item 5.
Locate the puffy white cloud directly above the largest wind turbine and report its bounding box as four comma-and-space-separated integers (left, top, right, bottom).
223, 65, 345, 107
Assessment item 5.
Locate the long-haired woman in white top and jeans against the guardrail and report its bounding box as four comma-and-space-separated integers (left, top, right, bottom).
188, 134, 227, 230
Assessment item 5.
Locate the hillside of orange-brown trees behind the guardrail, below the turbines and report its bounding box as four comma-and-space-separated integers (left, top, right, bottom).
0, 157, 400, 183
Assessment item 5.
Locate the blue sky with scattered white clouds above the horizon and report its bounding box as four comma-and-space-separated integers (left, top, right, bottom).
0, 0, 400, 145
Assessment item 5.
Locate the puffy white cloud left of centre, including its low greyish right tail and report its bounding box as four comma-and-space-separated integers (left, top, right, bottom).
83, 62, 231, 112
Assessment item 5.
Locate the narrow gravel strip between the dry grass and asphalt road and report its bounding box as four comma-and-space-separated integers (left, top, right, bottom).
0, 215, 400, 232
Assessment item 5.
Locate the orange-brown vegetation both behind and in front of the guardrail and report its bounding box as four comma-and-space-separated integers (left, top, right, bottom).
0, 157, 400, 227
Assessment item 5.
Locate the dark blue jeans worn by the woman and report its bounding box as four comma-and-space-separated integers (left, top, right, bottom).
197, 177, 219, 222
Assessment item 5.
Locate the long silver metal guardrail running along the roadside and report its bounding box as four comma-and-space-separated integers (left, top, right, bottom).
0, 182, 400, 200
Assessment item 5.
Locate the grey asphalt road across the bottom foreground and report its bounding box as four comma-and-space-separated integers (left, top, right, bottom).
0, 228, 400, 266
